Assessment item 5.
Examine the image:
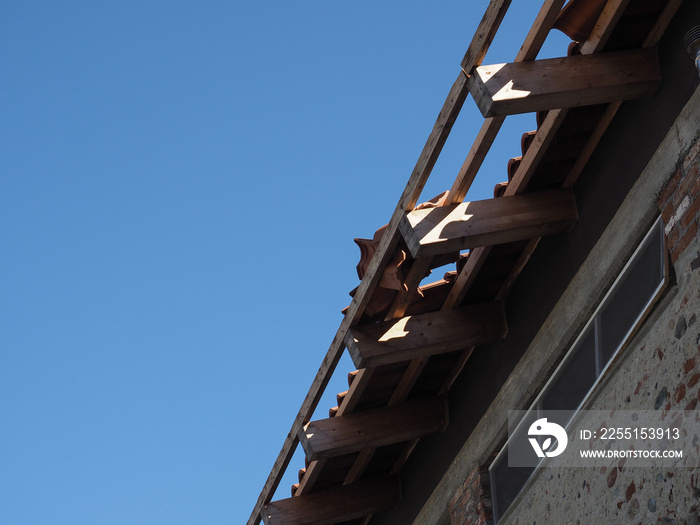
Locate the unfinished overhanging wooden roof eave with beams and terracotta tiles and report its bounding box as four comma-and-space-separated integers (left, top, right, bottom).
248, 0, 681, 525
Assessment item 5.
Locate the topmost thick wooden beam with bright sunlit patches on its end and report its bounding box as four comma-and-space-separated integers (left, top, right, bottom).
469, 49, 661, 118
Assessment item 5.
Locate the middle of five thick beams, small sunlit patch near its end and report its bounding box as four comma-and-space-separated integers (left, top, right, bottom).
346, 303, 508, 367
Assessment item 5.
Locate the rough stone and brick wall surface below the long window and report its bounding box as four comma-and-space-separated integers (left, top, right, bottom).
492, 134, 700, 525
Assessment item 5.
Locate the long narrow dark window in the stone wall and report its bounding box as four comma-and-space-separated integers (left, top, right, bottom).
489, 218, 668, 522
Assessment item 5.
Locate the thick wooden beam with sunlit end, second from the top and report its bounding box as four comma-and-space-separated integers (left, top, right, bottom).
401, 189, 578, 257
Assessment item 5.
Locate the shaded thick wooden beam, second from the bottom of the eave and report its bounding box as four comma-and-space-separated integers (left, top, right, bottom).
299, 397, 448, 461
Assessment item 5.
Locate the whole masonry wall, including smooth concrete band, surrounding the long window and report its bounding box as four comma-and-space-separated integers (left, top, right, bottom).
410, 69, 700, 525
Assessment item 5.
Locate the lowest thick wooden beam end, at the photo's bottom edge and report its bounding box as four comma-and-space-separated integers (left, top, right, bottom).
262, 476, 401, 525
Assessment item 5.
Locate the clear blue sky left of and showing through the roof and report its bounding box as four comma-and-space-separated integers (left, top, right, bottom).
0, 0, 566, 525
